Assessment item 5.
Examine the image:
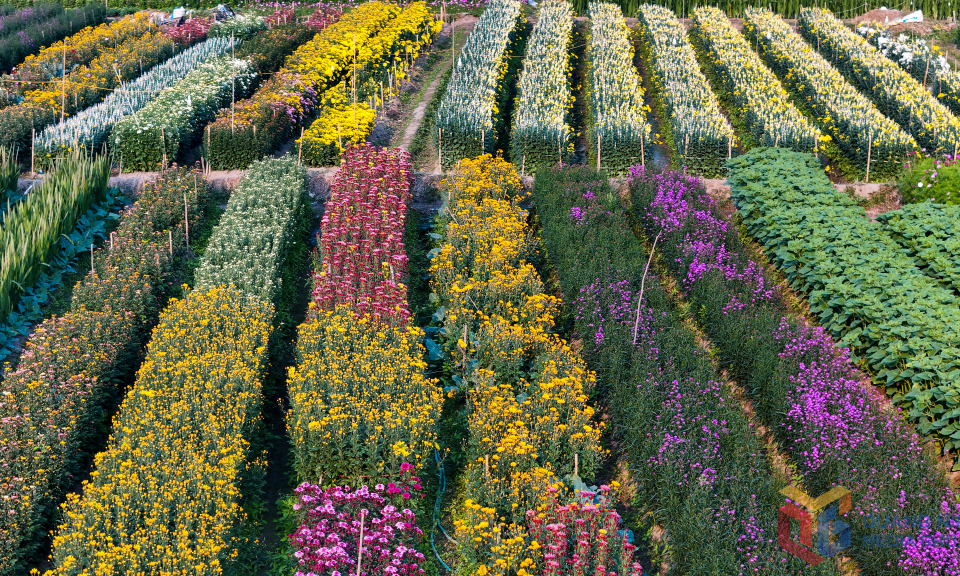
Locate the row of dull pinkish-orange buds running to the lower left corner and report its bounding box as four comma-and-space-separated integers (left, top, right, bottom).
0, 164, 206, 574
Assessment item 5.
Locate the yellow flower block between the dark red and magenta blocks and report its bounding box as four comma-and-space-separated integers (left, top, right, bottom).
287, 306, 443, 483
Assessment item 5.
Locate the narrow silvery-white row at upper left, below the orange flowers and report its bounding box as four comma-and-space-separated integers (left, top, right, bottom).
36, 38, 240, 157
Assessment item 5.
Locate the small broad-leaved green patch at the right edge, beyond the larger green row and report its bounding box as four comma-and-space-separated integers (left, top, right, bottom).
877, 202, 960, 293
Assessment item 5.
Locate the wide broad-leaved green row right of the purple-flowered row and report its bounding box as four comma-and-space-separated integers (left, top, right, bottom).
727, 148, 960, 451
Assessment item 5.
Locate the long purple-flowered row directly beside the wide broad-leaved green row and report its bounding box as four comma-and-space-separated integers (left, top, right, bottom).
630, 160, 952, 574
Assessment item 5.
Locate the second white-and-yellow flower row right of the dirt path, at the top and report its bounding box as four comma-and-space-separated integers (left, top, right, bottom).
510, 0, 573, 173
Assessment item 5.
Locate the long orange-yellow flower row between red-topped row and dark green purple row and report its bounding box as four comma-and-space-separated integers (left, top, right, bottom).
430, 155, 602, 575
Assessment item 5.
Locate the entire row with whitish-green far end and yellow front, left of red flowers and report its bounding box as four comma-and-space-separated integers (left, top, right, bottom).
39, 157, 306, 576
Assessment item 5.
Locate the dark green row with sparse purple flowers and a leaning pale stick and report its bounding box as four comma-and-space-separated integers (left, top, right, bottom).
533, 166, 839, 575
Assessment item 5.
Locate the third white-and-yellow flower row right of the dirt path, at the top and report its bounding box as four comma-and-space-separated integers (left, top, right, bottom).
586, 2, 654, 174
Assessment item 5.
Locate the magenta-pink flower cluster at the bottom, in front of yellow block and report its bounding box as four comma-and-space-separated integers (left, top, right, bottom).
289, 464, 424, 576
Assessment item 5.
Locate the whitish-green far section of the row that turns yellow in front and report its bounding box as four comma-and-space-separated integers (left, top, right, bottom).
196, 157, 306, 302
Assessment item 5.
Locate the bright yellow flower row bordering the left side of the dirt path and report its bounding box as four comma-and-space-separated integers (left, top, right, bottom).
297, 2, 442, 166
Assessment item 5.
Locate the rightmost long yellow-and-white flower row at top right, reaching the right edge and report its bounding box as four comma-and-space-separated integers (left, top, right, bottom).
797, 8, 960, 154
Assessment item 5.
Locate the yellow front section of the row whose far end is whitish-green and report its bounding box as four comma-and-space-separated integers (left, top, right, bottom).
47, 287, 273, 576
